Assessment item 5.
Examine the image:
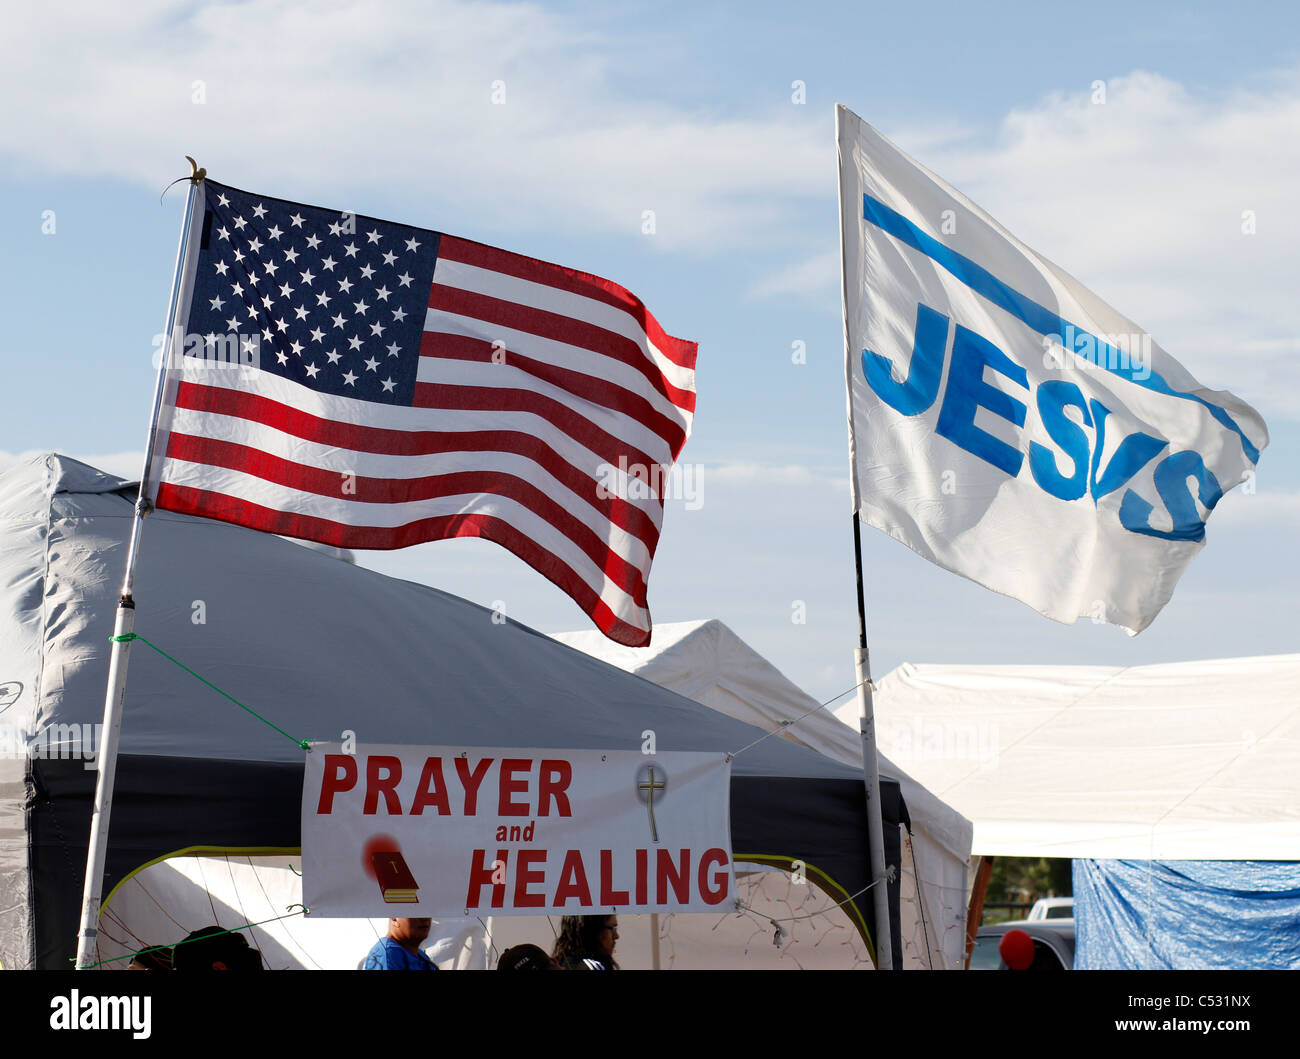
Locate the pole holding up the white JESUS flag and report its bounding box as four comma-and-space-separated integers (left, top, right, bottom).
835, 108, 893, 971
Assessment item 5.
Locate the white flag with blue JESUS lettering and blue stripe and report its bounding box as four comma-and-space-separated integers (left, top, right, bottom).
836, 107, 1269, 633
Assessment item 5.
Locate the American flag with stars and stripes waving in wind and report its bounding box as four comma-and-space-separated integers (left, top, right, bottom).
150, 181, 696, 646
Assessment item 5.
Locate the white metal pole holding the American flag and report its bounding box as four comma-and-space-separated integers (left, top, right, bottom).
75, 157, 207, 971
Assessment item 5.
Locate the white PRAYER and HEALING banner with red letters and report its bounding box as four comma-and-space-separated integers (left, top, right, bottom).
303, 743, 736, 917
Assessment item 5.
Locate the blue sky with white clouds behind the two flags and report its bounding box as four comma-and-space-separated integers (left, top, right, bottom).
0, 0, 1300, 698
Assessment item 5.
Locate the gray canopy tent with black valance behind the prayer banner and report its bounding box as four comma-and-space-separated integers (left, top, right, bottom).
0, 453, 907, 969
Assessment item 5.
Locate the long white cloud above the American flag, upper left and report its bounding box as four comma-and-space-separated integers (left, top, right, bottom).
0, 0, 833, 248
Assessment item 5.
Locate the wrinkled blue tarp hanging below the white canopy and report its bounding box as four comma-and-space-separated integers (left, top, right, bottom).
1074, 860, 1300, 971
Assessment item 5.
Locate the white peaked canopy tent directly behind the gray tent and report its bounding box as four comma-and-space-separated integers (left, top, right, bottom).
555, 620, 971, 969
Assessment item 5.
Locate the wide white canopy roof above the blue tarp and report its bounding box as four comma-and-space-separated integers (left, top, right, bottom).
837, 655, 1300, 860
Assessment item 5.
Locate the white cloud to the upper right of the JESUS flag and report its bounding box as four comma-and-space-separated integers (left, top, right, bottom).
902, 71, 1300, 417
